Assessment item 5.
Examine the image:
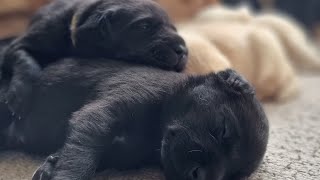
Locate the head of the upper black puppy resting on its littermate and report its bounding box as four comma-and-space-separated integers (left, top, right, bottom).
71, 0, 188, 71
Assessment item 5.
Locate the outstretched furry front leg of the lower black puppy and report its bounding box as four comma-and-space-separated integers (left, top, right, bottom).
33, 104, 118, 180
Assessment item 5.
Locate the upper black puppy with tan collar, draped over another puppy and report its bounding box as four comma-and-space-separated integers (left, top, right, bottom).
2, 0, 187, 119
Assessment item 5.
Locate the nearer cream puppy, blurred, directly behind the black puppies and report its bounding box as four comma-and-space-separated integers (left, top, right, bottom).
180, 22, 297, 100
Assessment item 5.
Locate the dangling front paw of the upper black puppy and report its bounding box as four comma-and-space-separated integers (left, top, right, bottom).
5, 80, 32, 119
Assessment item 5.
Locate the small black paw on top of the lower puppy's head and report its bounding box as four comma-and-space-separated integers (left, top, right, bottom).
217, 69, 255, 95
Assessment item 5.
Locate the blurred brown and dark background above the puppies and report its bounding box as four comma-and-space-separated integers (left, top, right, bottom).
0, 0, 320, 42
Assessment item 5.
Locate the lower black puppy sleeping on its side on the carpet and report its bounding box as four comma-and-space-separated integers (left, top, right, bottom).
0, 39, 268, 180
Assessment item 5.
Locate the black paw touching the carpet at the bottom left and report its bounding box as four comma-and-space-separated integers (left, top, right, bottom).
32, 155, 58, 180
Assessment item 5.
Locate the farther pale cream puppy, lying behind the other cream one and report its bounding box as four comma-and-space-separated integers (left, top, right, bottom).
195, 6, 320, 73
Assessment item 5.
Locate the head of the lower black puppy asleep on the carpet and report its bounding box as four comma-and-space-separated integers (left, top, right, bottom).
161, 71, 268, 180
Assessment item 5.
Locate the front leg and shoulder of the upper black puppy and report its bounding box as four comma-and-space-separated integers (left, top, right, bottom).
1, 10, 70, 117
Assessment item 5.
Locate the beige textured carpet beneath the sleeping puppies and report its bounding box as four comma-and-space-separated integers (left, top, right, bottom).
0, 77, 320, 180
